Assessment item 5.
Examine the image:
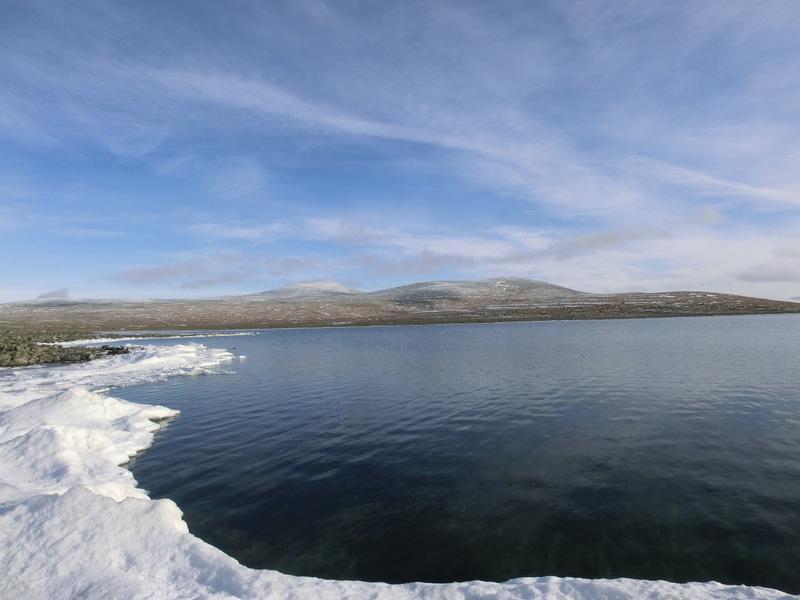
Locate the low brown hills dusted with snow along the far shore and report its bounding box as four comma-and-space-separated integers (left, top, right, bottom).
0, 277, 800, 331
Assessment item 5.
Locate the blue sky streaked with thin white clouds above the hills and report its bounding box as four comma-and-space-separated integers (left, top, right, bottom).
0, 0, 800, 302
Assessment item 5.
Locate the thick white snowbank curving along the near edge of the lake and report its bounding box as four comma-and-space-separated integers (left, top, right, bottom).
0, 343, 790, 600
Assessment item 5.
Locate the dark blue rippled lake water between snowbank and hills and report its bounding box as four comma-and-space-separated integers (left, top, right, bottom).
115, 316, 800, 592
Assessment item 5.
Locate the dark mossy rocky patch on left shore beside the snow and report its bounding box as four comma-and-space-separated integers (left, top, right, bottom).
0, 331, 130, 367
